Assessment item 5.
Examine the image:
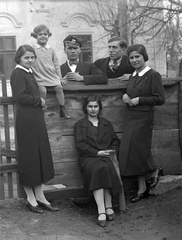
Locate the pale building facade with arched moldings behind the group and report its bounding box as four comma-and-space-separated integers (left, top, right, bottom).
0, 0, 166, 77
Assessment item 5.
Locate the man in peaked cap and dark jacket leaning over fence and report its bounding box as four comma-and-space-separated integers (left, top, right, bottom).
60, 35, 108, 85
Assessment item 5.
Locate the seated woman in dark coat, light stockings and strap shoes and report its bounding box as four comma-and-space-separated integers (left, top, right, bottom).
74, 95, 122, 227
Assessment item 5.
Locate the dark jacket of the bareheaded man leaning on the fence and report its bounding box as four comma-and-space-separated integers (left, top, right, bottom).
94, 55, 135, 78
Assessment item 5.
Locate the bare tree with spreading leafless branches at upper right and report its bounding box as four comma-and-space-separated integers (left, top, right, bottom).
83, 0, 182, 73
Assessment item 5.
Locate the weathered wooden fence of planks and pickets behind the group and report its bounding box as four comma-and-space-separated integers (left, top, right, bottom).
0, 77, 182, 199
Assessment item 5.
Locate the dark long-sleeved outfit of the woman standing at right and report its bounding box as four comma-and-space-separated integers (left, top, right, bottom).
119, 69, 165, 176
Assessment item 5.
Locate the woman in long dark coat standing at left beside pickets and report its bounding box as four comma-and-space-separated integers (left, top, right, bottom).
10, 45, 57, 213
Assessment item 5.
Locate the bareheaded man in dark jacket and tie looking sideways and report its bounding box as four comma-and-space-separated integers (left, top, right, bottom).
94, 36, 135, 78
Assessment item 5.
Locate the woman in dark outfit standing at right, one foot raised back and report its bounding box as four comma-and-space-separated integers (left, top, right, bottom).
119, 44, 165, 202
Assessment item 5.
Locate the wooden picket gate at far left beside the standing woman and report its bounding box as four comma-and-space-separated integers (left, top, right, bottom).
0, 75, 20, 199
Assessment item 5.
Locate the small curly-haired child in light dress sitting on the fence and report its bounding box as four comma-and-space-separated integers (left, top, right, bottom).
31, 25, 71, 118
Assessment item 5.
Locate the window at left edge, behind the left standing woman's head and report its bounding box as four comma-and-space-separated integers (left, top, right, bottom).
0, 36, 16, 78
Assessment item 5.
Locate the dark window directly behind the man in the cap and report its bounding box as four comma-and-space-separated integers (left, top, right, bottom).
74, 34, 93, 62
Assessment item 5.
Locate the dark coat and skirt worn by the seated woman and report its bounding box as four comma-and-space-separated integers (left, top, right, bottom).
74, 117, 122, 193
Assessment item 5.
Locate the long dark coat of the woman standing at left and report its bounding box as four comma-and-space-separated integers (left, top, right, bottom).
10, 68, 54, 186
